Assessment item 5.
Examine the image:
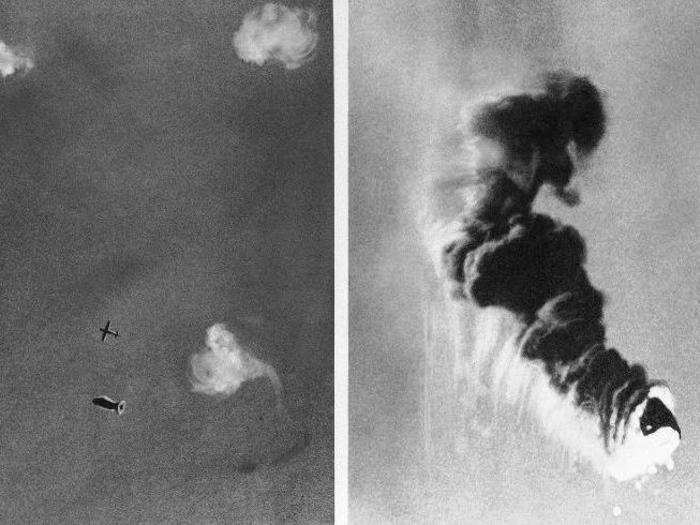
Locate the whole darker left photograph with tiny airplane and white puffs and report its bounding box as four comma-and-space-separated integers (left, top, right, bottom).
0, 0, 334, 523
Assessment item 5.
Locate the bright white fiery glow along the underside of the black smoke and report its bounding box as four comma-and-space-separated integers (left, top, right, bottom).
464, 307, 680, 482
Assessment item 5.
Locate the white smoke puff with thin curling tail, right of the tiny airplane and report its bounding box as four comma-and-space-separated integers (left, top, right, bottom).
190, 324, 282, 406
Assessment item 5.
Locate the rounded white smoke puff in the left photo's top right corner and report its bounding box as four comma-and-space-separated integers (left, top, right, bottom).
233, 3, 318, 69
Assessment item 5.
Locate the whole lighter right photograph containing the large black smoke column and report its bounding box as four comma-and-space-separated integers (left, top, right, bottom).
348, 0, 700, 524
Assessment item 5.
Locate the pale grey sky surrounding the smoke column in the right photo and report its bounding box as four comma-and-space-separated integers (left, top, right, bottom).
349, 0, 700, 523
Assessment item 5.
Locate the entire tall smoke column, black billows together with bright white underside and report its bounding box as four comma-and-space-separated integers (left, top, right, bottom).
426, 71, 680, 481
